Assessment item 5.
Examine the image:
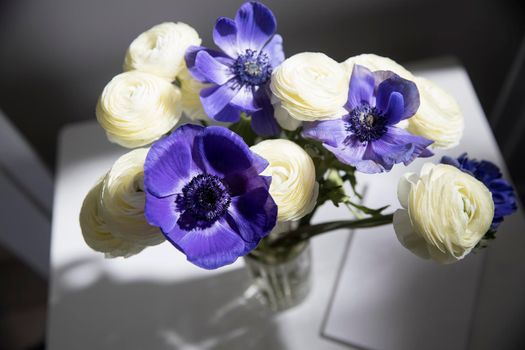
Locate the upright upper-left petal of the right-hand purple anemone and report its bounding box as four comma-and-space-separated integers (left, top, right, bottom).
345, 64, 375, 111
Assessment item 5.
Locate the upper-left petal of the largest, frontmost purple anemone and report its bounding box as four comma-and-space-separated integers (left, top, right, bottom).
144, 124, 203, 197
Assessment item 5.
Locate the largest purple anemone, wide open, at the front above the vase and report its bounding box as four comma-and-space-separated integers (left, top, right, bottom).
144, 125, 277, 269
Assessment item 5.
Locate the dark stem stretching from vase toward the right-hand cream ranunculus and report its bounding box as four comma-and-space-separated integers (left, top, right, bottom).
268, 214, 394, 247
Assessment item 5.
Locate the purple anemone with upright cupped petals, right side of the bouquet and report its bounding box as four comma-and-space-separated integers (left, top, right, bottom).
303, 65, 432, 173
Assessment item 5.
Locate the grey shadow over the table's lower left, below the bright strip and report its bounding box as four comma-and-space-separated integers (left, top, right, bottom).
48, 260, 284, 350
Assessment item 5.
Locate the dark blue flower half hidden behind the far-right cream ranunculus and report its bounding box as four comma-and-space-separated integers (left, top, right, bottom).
441, 153, 517, 231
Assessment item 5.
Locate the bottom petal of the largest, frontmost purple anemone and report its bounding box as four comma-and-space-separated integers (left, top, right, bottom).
173, 220, 245, 270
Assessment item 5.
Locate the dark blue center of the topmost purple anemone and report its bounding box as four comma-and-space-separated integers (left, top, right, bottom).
232, 49, 272, 85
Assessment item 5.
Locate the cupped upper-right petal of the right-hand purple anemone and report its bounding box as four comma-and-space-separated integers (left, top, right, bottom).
374, 71, 419, 119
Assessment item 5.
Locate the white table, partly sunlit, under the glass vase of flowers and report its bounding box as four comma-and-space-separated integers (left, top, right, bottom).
47, 63, 525, 350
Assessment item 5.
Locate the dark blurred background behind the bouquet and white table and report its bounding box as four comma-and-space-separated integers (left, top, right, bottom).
0, 0, 525, 348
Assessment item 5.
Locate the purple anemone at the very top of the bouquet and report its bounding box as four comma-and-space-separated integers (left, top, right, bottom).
186, 2, 284, 136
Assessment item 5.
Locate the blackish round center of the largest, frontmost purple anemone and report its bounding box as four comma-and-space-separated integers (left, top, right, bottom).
176, 174, 231, 230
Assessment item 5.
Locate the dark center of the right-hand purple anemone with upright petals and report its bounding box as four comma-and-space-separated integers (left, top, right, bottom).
345, 105, 387, 142
